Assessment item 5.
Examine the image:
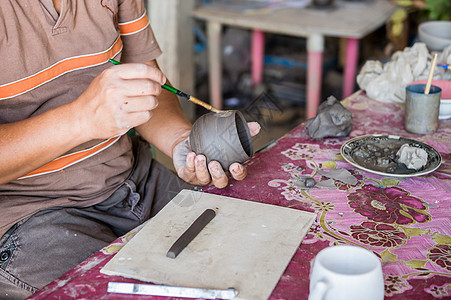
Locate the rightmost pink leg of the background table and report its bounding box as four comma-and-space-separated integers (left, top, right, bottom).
342, 38, 359, 99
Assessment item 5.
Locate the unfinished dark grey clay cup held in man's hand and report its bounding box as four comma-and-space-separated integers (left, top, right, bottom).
189, 110, 254, 170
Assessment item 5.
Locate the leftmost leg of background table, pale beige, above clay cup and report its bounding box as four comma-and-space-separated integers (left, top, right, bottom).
207, 21, 222, 109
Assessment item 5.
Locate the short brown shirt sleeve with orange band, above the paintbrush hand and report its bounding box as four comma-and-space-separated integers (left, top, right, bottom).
118, 0, 162, 62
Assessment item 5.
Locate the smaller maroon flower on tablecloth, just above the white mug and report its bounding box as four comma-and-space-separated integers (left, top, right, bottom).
350, 222, 407, 248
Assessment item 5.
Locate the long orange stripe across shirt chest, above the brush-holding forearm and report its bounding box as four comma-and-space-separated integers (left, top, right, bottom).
0, 38, 122, 100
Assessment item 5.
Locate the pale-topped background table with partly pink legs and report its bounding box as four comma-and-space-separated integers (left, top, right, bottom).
193, 0, 396, 118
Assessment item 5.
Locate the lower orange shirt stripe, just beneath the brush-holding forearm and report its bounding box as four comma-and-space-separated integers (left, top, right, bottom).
19, 136, 121, 179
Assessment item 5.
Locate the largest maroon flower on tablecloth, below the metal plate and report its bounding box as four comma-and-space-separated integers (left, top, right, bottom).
347, 185, 431, 225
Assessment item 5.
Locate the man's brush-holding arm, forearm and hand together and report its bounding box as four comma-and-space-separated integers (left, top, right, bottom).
0, 64, 166, 184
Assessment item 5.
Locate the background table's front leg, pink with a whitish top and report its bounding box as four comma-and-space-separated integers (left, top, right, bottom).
307, 34, 324, 119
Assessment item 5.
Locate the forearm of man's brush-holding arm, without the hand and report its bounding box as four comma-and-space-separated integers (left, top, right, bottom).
0, 101, 87, 184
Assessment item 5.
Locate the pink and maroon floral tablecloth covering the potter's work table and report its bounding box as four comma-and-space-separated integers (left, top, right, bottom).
30, 92, 451, 300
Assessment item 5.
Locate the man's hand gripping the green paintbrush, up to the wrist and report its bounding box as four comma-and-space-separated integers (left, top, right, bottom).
76, 63, 166, 139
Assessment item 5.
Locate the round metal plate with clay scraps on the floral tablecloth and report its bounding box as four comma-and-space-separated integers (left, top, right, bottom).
340, 134, 442, 177
